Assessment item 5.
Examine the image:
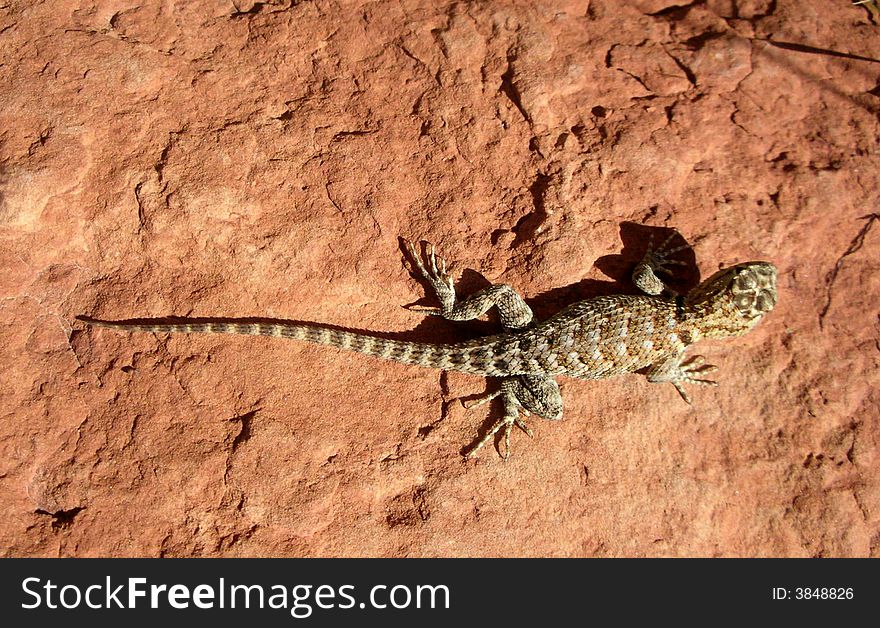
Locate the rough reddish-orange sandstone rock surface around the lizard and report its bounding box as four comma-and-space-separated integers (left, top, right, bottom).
0, 0, 880, 556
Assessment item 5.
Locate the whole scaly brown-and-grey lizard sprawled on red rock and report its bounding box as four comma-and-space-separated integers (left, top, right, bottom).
76, 232, 777, 460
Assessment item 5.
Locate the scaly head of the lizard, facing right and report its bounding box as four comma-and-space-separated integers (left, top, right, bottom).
686, 262, 777, 338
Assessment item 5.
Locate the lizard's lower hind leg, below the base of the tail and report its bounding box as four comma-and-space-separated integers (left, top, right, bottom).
464, 375, 562, 460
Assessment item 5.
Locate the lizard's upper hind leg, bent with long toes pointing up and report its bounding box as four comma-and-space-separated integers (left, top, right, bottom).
405, 241, 535, 331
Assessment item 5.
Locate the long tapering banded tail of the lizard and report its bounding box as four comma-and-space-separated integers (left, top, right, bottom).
76, 316, 501, 376
